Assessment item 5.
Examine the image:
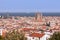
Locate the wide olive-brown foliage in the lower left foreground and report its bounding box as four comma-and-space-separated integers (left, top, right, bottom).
0, 31, 26, 40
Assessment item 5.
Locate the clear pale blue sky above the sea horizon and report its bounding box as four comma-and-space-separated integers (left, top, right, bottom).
0, 0, 60, 12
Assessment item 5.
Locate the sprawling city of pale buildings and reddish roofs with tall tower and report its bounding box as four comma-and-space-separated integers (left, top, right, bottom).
0, 13, 60, 40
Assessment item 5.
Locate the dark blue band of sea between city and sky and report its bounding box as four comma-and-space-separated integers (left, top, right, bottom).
0, 12, 60, 16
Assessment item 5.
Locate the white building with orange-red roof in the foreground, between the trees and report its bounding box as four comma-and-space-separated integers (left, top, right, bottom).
26, 33, 50, 40
